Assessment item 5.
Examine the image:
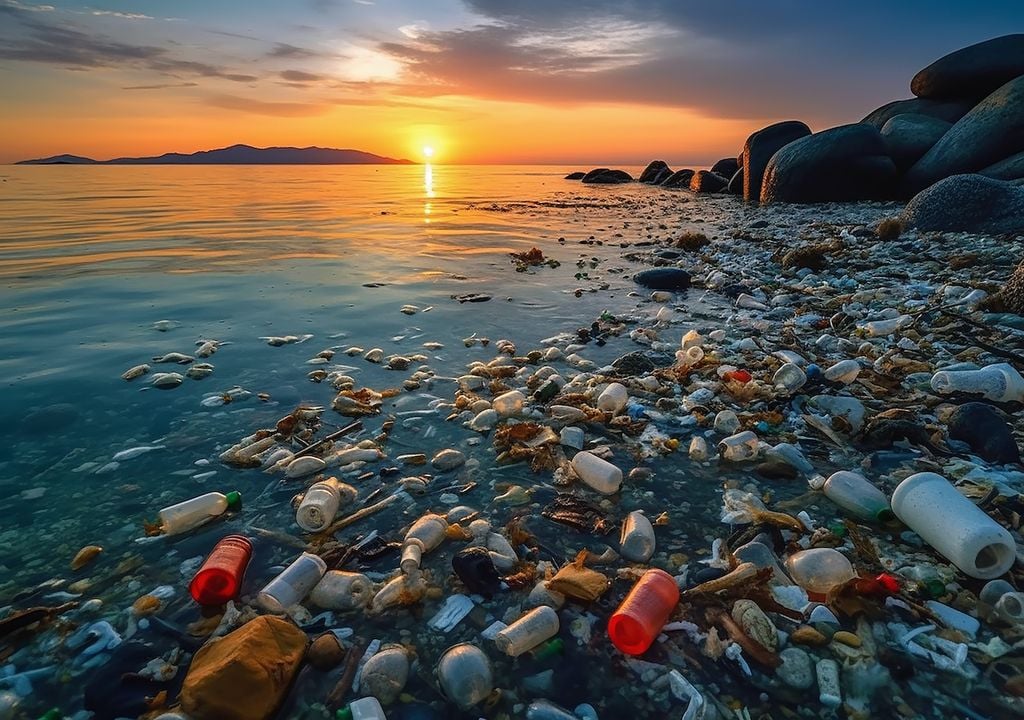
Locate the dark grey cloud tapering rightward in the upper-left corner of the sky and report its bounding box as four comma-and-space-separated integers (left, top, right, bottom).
0, 5, 259, 83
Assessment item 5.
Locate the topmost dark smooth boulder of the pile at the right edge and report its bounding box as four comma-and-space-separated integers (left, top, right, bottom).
910, 34, 1024, 99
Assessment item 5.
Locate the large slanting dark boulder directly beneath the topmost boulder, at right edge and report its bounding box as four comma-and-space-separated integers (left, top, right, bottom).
903, 77, 1024, 193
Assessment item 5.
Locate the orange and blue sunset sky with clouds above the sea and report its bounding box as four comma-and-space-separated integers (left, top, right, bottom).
0, 0, 1024, 166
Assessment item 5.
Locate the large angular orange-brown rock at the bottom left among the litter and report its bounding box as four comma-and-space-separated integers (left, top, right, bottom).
180, 616, 307, 720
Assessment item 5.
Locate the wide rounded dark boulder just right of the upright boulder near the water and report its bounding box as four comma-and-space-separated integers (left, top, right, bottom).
761, 123, 897, 203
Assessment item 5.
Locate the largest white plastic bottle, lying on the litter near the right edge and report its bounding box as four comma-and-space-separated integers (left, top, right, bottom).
892, 472, 1017, 580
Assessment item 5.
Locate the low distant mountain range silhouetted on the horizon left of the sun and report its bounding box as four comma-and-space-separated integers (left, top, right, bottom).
14, 144, 413, 165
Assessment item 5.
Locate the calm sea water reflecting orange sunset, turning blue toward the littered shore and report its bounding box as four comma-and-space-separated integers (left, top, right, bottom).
0, 166, 737, 718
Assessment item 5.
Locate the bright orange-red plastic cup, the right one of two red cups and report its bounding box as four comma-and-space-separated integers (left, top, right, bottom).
608, 569, 679, 655
